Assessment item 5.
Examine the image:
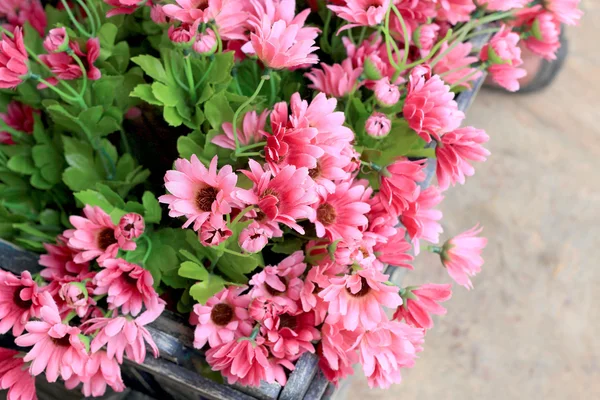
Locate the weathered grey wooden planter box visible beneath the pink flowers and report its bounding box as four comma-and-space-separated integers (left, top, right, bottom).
0, 42, 483, 400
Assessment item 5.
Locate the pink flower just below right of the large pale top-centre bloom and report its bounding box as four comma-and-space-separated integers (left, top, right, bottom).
304, 58, 363, 98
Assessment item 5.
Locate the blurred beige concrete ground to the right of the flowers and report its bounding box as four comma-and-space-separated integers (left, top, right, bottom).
343, 0, 600, 400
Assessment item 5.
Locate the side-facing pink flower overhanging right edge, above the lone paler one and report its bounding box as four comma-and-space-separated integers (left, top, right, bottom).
435, 126, 490, 190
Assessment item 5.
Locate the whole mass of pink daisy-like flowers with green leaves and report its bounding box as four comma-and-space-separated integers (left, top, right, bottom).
0, 0, 582, 399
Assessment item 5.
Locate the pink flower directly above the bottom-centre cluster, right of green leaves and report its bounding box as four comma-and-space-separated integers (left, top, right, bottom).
249, 250, 306, 312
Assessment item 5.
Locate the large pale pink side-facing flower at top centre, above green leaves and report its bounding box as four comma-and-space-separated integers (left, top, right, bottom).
242, 14, 319, 69
